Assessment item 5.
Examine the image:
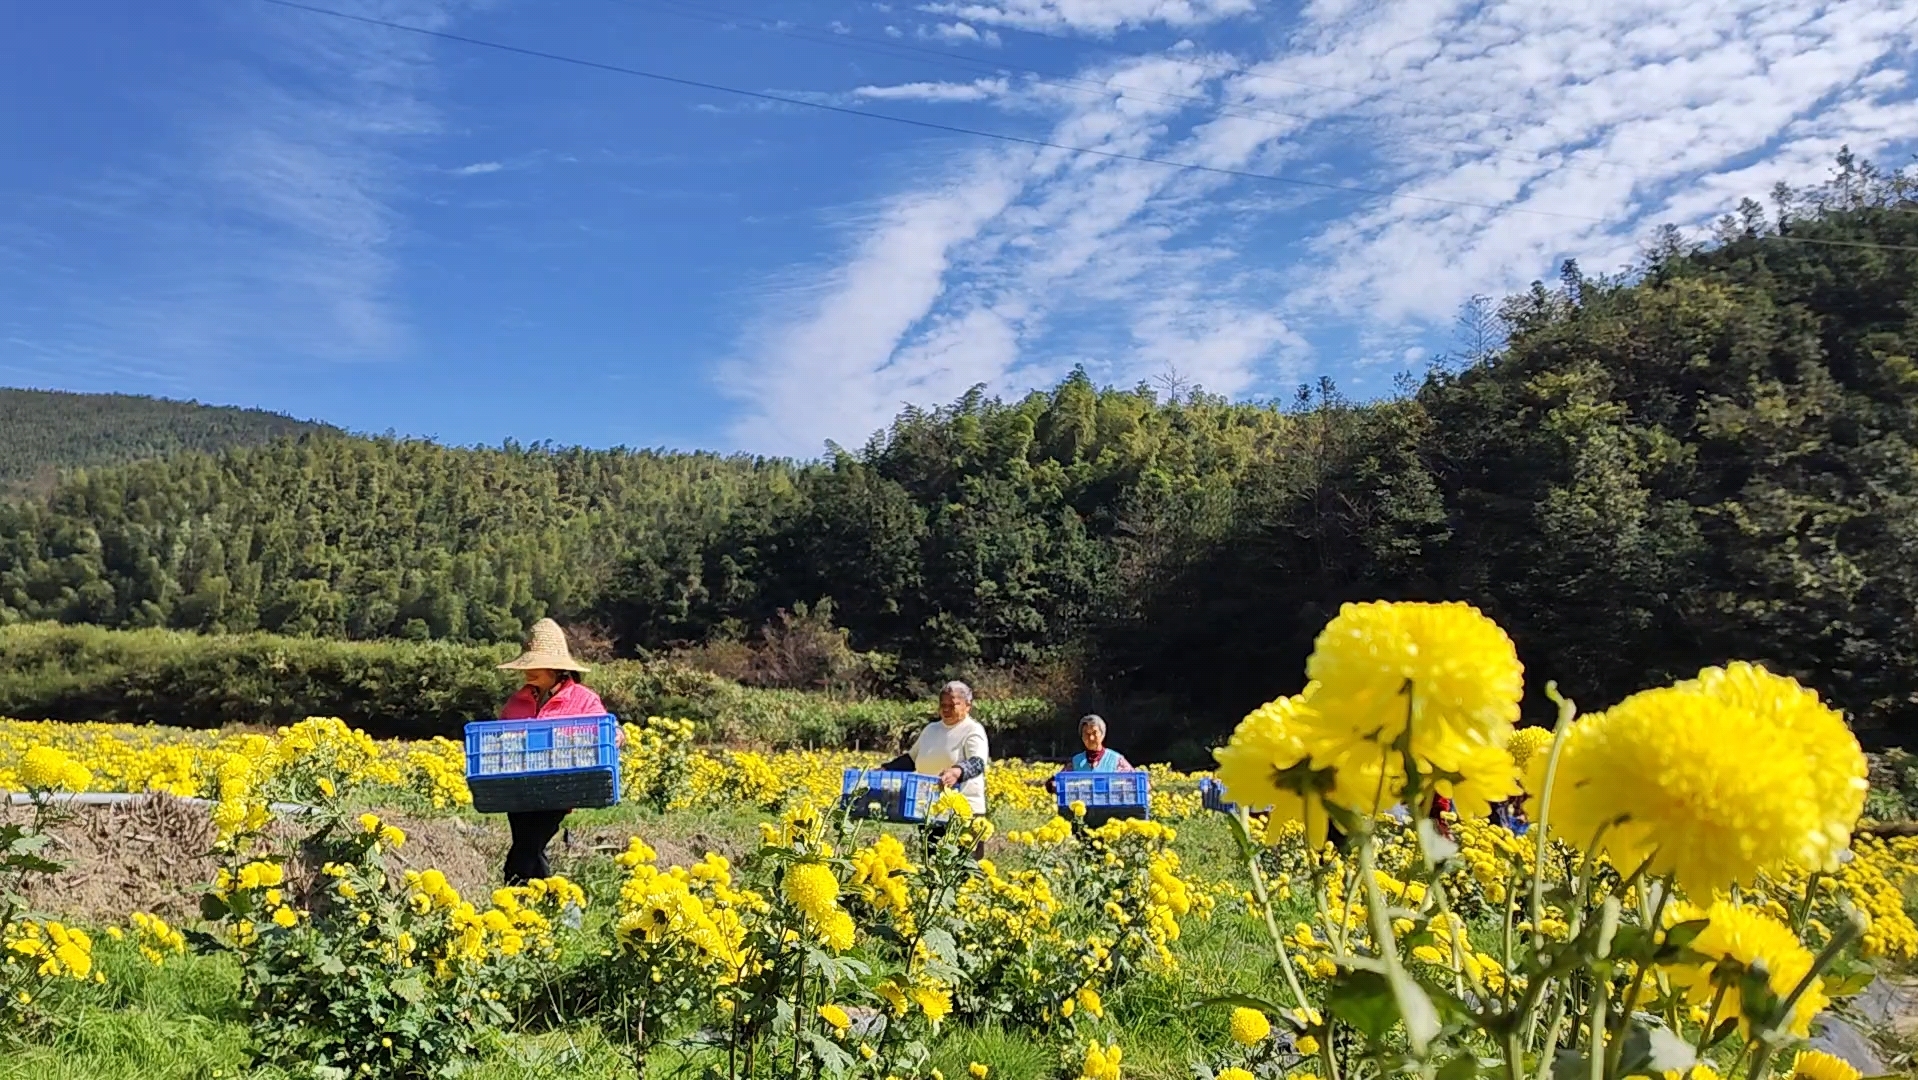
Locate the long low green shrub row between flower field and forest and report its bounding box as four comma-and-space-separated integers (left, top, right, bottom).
0, 623, 1076, 754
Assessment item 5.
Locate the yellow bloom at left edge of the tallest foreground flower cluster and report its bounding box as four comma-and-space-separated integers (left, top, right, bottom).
1212, 694, 1331, 848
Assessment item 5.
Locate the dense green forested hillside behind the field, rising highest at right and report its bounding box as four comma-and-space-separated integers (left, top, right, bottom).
0, 157, 1918, 744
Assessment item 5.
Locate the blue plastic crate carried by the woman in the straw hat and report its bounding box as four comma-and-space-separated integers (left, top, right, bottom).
466, 716, 620, 813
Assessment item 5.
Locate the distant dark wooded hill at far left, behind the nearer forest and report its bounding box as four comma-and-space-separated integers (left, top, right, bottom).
0, 387, 330, 495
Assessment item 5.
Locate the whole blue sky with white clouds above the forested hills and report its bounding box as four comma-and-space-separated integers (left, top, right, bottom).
0, 0, 1918, 455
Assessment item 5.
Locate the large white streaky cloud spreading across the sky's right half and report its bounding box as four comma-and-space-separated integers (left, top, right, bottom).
731, 0, 1918, 453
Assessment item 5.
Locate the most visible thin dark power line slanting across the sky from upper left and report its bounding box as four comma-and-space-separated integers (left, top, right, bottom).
261, 0, 1607, 224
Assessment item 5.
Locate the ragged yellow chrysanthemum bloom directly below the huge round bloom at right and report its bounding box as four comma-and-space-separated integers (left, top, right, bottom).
1665, 900, 1830, 1038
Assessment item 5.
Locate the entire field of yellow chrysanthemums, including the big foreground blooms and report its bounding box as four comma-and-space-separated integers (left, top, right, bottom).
0, 604, 1918, 1080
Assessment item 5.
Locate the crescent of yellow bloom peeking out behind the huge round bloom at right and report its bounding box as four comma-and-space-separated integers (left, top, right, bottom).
1678, 660, 1870, 873
